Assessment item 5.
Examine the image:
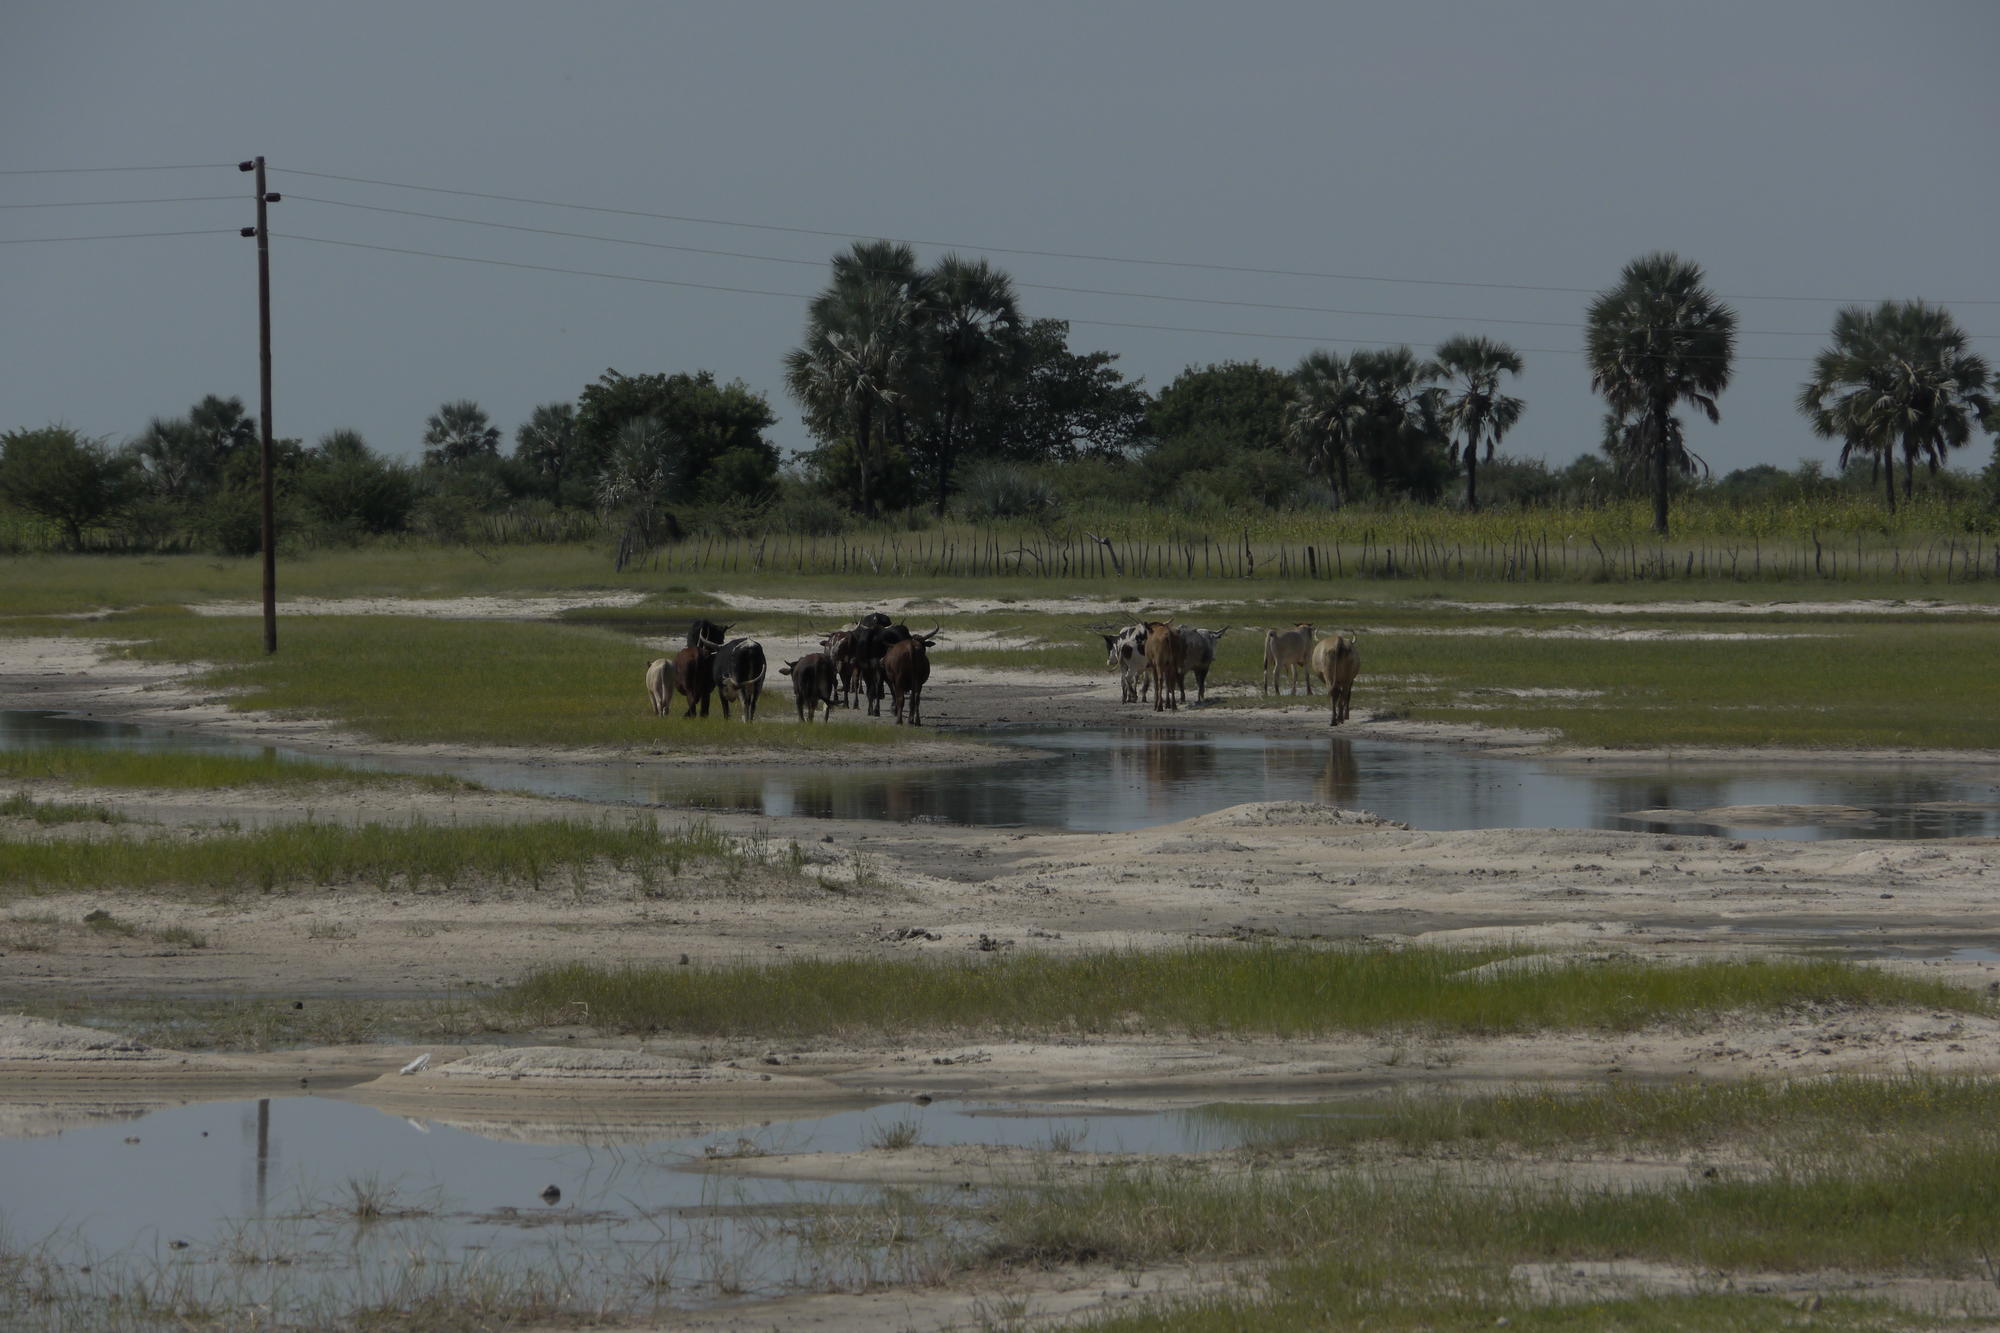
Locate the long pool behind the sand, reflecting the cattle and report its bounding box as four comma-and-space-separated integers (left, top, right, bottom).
0, 711, 2000, 839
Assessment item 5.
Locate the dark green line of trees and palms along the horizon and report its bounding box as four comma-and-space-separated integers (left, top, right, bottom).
0, 249, 2000, 554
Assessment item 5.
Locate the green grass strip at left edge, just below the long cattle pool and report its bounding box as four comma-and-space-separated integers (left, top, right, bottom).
0, 817, 744, 901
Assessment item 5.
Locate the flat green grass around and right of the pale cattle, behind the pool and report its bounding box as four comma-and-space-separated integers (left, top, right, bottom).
936, 600, 2000, 749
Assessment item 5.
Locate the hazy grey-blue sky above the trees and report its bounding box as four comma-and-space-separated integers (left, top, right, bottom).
0, 0, 2000, 474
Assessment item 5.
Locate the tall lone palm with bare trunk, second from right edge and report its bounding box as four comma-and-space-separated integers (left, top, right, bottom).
1584, 252, 1736, 536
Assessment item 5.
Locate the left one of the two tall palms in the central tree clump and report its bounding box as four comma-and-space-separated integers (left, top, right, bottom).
784, 240, 924, 518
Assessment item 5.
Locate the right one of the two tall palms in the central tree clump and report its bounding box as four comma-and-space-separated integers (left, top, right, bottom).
924, 254, 1028, 516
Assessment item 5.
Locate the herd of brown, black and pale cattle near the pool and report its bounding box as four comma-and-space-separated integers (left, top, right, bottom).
646, 610, 1362, 727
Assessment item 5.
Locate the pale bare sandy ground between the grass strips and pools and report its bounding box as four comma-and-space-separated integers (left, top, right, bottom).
11, 598, 2000, 1329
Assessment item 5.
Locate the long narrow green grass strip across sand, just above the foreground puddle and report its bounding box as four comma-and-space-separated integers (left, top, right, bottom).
502, 947, 1988, 1037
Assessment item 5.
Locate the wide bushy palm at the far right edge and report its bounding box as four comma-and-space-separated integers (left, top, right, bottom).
1798, 300, 1994, 512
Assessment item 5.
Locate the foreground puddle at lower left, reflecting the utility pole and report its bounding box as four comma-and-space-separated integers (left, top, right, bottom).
0, 1097, 1248, 1315
